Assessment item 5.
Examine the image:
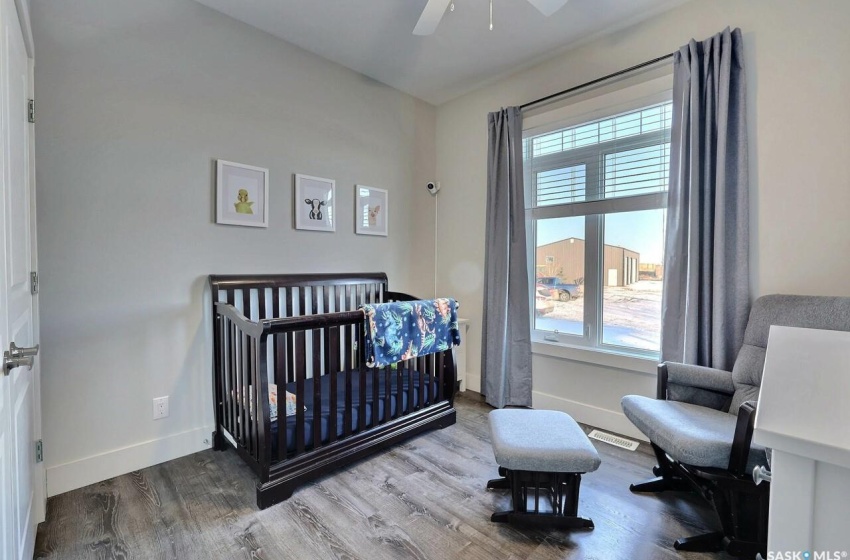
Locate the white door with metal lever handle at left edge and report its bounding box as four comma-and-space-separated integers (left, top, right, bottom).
0, 0, 39, 560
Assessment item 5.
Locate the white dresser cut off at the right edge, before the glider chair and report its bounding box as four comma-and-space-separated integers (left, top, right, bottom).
753, 326, 850, 560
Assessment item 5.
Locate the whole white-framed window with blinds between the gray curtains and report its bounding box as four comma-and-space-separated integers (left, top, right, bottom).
523, 101, 671, 357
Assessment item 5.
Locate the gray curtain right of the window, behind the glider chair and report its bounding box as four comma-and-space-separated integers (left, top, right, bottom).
661, 28, 750, 370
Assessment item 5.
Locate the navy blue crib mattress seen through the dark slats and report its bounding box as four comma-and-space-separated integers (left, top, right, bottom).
271, 370, 437, 455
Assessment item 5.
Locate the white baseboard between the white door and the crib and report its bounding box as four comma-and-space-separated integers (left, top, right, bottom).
47, 426, 213, 496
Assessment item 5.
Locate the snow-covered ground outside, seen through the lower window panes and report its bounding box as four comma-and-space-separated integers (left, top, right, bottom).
536, 280, 663, 350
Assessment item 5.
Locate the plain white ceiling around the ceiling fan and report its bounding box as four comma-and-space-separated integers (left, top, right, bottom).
197, 0, 685, 105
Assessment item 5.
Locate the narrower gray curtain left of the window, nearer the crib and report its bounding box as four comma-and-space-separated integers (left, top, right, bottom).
481, 107, 531, 408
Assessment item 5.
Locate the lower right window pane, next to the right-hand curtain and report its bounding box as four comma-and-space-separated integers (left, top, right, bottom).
602, 209, 666, 352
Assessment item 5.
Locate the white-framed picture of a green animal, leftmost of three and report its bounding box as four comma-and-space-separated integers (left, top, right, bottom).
215, 159, 269, 227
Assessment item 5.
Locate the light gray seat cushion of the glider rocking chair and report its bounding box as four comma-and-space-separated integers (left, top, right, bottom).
622, 395, 767, 472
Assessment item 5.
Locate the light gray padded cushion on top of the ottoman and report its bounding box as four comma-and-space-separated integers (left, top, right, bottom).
489, 409, 601, 473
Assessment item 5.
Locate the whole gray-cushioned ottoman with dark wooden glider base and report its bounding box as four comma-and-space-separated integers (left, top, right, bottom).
487, 409, 601, 529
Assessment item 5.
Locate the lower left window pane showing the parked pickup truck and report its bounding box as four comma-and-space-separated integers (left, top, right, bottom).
534, 216, 585, 336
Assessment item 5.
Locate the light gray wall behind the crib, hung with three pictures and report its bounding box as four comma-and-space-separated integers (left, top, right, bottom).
32, 0, 436, 494
